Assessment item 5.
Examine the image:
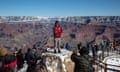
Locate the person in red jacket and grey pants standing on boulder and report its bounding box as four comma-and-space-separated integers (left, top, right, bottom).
53, 21, 62, 53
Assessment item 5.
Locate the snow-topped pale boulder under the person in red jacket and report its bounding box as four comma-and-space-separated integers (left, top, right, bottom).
43, 49, 74, 72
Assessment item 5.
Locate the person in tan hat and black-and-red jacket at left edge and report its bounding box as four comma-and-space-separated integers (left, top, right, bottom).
0, 48, 17, 72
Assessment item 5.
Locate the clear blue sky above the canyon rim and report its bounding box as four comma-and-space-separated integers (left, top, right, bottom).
0, 0, 120, 16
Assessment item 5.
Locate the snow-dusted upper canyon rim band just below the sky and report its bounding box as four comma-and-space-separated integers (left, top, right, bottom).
0, 16, 120, 24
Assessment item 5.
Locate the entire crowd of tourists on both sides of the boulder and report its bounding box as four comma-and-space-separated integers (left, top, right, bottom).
0, 40, 117, 72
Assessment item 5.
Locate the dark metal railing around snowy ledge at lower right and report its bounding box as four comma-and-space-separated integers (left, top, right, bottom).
94, 46, 120, 72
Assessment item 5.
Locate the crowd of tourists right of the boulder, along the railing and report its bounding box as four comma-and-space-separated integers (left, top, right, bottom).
71, 40, 120, 72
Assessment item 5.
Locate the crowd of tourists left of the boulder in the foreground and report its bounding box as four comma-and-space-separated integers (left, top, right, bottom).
0, 44, 46, 72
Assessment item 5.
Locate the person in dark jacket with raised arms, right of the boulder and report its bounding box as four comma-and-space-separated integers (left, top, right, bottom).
71, 47, 94, 72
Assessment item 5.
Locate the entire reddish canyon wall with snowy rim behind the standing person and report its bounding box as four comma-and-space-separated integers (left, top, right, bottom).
0, 16, 120, 47
